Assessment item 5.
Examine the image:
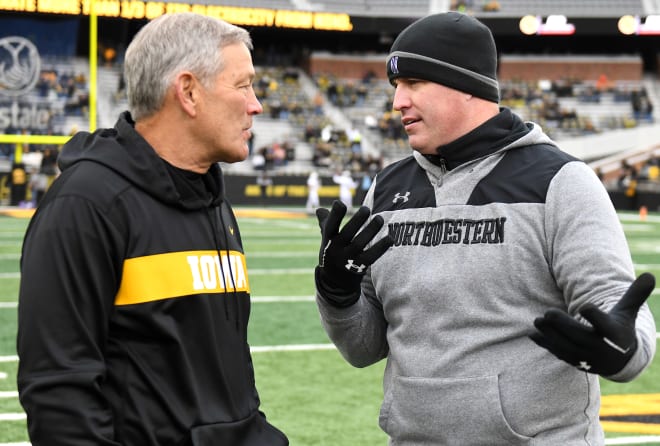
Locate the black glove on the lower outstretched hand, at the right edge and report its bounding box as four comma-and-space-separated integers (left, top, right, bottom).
530, 273, 655, 376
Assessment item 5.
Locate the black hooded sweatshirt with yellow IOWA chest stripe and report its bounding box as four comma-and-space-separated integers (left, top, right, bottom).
17, 113, 288, 446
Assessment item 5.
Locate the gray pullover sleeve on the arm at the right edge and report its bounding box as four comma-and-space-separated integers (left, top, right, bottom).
545, 162, 656, 382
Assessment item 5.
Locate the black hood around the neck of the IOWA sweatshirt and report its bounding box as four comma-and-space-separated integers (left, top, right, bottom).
57, 112, 224, 210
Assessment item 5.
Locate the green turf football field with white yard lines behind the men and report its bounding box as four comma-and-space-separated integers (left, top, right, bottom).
0, 209, 660, 446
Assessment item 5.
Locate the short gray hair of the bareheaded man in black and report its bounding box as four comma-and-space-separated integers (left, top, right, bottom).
124, 12, 252, 121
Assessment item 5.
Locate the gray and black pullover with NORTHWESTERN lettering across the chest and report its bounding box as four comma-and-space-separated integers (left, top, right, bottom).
317, 109, 656, 446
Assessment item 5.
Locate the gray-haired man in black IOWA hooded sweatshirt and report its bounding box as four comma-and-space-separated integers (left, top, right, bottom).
17, 13, 288, 446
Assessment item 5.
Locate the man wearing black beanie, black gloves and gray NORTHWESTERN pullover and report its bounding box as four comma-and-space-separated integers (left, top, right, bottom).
315, 12, 656, 446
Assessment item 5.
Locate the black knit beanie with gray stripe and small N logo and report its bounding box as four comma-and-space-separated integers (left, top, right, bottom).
387, 12, 500, 102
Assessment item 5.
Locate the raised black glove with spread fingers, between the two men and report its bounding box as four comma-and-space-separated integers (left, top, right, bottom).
314, 200, 393, 307
